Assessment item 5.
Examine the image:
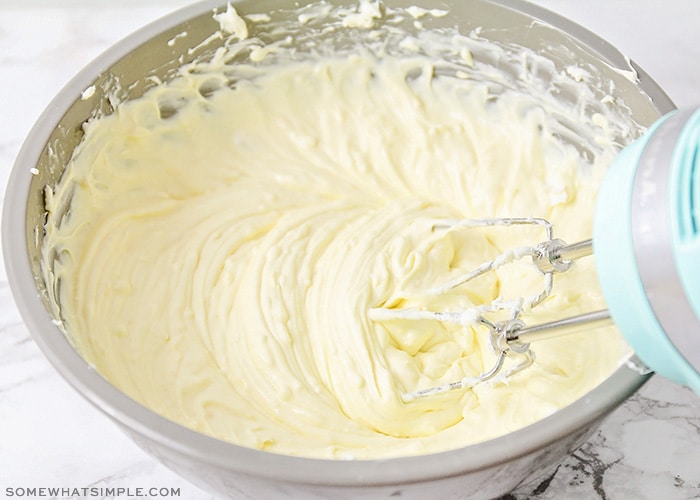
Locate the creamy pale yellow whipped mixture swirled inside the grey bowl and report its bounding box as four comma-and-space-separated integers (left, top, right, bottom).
45, 1, 626, 458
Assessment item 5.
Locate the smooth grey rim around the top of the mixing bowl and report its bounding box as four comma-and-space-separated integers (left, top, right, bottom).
1, 0, 675, 486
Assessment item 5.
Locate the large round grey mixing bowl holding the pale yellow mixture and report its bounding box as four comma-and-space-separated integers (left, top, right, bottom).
2, 0, 673, 499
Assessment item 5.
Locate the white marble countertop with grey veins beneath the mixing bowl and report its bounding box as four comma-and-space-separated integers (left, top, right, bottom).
0, 0, 700, 500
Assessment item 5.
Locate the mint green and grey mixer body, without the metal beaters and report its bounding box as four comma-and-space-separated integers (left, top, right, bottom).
593, 109, 700, 394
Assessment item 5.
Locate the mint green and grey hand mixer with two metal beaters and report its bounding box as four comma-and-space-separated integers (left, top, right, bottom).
378, 109, 700, 400
